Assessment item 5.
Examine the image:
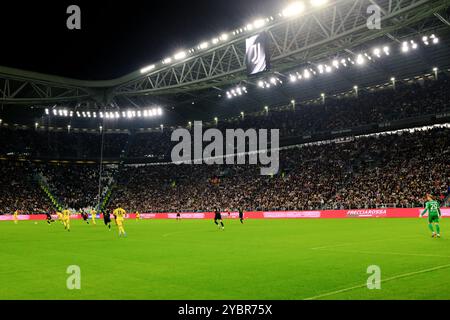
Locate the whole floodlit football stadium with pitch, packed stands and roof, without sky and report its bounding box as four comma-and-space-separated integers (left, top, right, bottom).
0, 0, 450, 302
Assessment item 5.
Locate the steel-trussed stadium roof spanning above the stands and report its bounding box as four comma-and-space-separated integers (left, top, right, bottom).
0, 0, 450, 126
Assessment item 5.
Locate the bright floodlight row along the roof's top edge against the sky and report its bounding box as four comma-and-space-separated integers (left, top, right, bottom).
140, 0, 328, 74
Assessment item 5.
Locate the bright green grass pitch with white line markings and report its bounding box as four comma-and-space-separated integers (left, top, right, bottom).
0, 219, 450, 300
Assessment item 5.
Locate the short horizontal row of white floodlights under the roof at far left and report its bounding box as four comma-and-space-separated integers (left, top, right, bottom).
45, 108, 163, 119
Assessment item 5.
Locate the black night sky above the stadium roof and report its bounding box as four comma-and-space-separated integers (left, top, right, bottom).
0, 0, 288, 80
